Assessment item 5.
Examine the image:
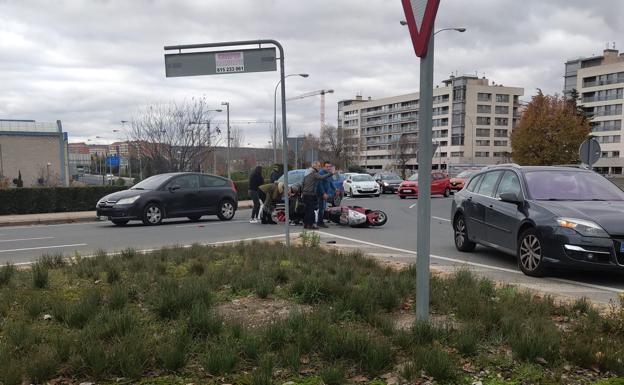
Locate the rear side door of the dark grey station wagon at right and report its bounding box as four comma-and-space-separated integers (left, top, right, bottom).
466, 171, 503, 242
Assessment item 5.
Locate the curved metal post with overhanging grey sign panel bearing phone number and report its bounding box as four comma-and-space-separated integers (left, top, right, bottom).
164, 39, 290, 247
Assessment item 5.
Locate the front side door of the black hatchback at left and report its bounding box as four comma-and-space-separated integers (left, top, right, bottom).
164, 174, 199, 217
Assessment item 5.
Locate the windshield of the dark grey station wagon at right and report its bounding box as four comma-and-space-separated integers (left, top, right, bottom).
525, 170, 624, 201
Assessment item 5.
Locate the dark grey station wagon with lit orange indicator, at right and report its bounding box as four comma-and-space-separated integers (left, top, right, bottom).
452, 165, 624, 276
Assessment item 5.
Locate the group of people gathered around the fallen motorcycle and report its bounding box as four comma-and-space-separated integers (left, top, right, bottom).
249, 161, 336, 229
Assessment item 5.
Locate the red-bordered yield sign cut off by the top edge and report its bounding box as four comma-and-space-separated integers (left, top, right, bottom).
401, 0, 440, 57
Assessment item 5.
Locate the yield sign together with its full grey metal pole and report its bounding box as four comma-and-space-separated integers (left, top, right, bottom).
401, 0, 440, 321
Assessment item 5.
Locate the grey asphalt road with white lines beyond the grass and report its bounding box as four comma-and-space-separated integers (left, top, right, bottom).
0, 195, 624, 303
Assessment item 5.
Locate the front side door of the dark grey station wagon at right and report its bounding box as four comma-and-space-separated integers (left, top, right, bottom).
485, 171, 524, 253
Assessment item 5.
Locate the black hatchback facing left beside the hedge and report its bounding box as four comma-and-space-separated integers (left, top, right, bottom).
97, 172, 238, 226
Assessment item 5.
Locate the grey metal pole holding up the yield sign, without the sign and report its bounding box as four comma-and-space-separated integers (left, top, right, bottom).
416, 35, 434, 321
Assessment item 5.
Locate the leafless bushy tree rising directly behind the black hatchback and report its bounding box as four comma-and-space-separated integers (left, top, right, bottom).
128, 98, 219, 174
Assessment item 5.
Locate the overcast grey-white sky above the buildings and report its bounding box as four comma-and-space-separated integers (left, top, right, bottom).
0, 0, 624, 146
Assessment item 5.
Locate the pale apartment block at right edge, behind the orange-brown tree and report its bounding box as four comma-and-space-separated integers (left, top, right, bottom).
564, 49, 624, 174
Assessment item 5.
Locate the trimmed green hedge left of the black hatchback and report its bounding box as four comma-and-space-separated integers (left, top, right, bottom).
0, 186, 125, 215
